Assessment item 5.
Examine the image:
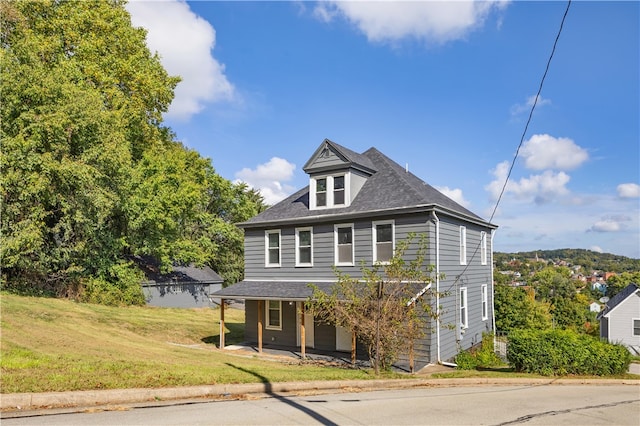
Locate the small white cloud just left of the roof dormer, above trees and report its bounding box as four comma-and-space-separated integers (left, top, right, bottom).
236, 157, 296, 205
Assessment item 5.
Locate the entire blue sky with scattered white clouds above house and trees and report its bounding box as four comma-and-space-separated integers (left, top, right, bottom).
127, 0, 640, 258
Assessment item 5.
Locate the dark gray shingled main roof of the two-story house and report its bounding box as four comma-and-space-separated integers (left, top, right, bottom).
239, 141, 495, 228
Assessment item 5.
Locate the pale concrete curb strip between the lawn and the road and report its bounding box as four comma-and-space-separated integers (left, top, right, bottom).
0, 378, 640, 414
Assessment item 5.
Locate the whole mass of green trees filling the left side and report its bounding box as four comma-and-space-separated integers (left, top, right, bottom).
0, 0, 264, 303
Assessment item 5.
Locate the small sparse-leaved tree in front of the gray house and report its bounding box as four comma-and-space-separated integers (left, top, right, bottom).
306, 236, 436, 374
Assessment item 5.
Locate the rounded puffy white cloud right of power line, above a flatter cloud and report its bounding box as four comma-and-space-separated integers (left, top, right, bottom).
520, 134, 589, 170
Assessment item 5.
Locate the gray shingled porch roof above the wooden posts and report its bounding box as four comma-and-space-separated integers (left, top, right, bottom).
212, 281, 335, 301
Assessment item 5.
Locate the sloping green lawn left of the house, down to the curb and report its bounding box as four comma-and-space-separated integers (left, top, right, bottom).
0, 293, 371, 393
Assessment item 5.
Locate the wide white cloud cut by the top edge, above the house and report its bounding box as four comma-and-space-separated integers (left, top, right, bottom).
314, 1, 508, 44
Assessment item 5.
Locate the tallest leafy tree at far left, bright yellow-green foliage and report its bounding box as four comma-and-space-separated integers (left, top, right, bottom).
0, 1, 178, 294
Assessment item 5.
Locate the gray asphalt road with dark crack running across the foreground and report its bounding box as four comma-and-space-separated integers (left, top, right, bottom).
2, 385, 640, 426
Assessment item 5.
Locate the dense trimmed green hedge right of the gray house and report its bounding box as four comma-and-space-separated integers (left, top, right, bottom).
507, 329, 631, 376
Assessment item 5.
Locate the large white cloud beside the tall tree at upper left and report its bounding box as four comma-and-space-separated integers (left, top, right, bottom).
126, 0, 234, 121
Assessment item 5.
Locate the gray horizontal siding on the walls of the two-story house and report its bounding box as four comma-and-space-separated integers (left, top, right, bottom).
245, 213, 493, 363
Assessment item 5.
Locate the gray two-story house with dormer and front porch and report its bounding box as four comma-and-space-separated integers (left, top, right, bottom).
215, 140, 497, 364
